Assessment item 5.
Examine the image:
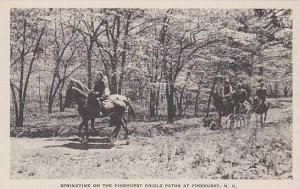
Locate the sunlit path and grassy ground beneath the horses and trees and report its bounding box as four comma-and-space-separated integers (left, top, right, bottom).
11, 99, 292, 179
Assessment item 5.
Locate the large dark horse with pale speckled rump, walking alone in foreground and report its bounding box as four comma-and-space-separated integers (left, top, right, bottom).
65, 79, 134, 144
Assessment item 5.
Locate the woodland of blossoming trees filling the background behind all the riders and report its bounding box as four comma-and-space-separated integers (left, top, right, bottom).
10, 9, 292, 127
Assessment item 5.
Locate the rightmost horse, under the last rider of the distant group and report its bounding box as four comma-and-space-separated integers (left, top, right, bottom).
253, 97, 270, 127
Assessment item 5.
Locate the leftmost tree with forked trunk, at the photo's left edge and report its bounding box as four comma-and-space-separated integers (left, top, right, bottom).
10, 9, 48, 127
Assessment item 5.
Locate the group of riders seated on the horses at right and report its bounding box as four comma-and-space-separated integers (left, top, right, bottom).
221, 79, 267, 113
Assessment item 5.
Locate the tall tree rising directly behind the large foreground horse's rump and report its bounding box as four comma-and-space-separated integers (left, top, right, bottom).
97, 9, 143, 94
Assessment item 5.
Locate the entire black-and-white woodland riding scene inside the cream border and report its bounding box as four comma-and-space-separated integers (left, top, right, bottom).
0, 0, 299, 188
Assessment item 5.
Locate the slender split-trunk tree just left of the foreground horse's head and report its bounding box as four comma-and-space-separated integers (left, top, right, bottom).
48, 9, 82, 113
